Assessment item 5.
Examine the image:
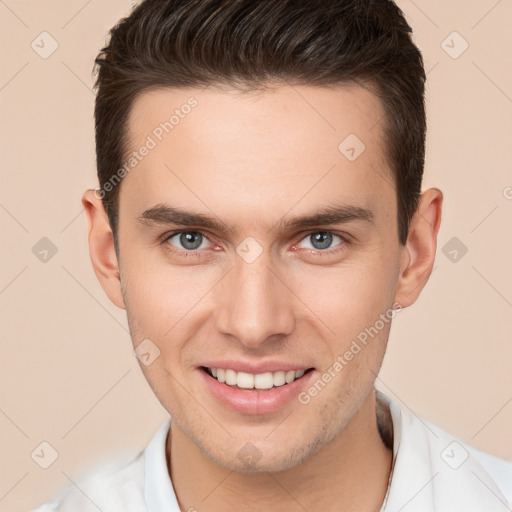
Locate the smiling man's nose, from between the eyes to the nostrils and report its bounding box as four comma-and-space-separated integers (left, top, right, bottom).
216, 252, 295, 349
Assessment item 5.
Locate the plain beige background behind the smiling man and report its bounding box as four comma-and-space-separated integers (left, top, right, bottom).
0, 0, 512, 512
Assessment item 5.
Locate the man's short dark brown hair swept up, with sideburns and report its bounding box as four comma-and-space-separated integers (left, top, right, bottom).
95, 0, 426, 249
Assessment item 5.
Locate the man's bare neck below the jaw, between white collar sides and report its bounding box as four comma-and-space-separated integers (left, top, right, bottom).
167, 391, 392, 512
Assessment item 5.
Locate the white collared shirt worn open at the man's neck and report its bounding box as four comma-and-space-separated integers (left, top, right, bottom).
32, 393, 512, 512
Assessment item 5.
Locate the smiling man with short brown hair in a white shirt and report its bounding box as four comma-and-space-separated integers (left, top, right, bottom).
34, 0, 512, 512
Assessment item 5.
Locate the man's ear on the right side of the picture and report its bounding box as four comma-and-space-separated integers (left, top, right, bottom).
395, 188, 443, 308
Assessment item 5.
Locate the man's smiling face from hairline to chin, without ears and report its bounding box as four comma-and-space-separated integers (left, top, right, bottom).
115, 85, 401, 471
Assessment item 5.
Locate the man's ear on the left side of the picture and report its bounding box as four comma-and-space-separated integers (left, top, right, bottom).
82, 189, 125, 309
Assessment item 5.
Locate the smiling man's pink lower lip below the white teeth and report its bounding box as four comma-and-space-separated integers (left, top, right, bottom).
198, 368, 315, 415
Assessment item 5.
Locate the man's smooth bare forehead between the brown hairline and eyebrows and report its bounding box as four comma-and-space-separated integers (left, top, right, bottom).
120, 85, 395, 234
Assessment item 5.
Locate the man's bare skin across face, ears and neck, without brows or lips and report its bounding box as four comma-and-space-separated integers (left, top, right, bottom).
83, 84, 443, 512
